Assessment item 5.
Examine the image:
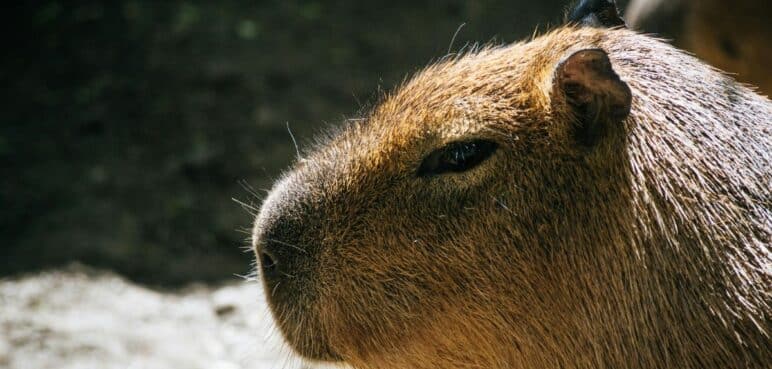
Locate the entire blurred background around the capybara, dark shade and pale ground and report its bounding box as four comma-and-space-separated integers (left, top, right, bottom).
0, 0, 772, 369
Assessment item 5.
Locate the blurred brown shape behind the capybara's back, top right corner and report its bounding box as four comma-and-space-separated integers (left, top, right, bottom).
626, 0, 772, 96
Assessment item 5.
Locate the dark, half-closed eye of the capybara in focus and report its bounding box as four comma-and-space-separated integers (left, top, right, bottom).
418, 140, 498, 177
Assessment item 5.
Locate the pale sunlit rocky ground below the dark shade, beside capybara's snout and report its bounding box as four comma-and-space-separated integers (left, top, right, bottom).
0, 266, 340, 369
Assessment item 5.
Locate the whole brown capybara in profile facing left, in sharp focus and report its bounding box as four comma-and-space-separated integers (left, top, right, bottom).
253, 0, 772, 369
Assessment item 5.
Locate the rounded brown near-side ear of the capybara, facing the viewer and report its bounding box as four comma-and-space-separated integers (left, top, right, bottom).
552, 49, 632, 146
